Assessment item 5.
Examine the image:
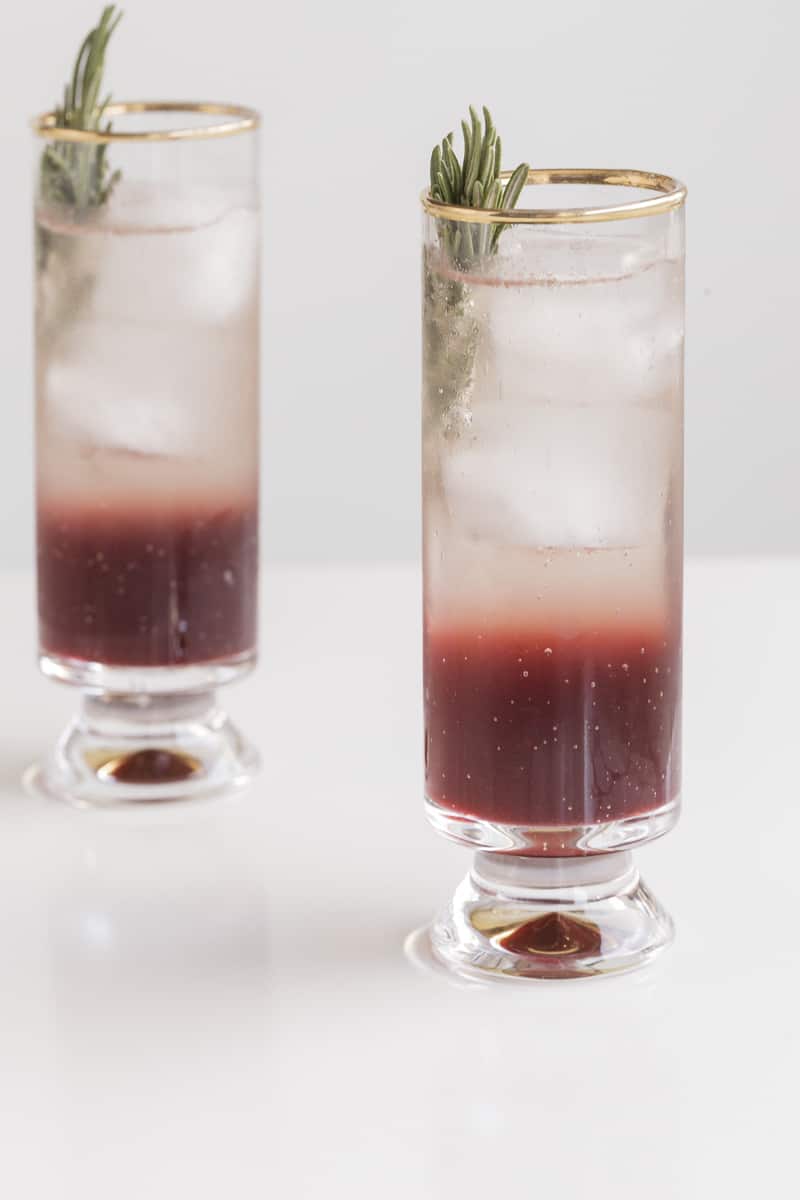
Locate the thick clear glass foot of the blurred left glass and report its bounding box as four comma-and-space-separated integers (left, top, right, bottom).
25, 691, 259, 808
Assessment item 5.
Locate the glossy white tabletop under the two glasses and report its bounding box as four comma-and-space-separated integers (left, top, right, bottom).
0, 559, 800, 1200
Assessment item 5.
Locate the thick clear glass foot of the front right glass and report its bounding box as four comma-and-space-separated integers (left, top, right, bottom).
429, 851, 673, 979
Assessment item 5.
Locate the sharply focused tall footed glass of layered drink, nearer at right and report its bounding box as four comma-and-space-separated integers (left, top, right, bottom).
423, 170, 685, 978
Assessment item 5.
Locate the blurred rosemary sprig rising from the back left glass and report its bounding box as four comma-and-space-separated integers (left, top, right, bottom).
40, 5, 122, 210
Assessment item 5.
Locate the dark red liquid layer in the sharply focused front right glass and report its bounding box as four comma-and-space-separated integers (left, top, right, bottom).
425, 628, 680, 835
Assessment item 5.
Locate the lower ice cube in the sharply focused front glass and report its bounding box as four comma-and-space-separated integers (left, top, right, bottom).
441, 403, 672, 547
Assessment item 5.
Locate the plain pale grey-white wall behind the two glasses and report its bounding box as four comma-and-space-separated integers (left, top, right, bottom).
0, 0, 800, 565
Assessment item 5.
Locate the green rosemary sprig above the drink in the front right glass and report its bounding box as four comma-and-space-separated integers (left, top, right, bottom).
431, 104, 530, 266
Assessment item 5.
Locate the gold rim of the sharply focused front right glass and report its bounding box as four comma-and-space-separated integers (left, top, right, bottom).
422, 167, 686, 224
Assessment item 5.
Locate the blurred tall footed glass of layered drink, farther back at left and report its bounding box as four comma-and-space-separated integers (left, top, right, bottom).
31, 103, 259, 805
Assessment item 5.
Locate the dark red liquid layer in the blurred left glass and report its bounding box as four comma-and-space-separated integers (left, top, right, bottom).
38, 505, 258, 667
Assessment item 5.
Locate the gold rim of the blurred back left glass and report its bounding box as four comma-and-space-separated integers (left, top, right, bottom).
34, 100, 260, 144
